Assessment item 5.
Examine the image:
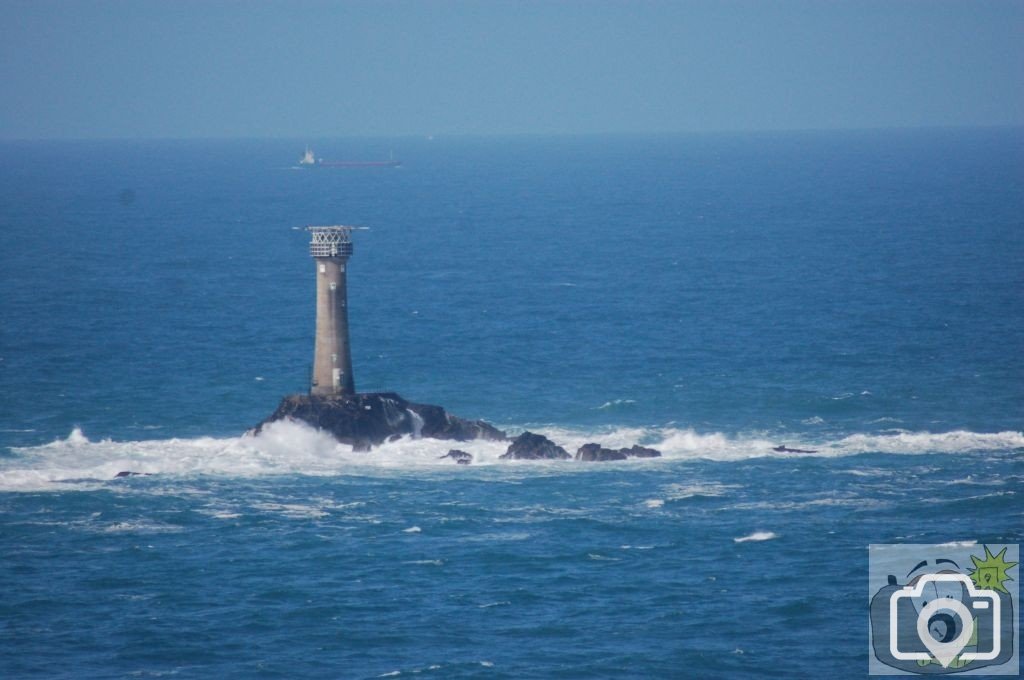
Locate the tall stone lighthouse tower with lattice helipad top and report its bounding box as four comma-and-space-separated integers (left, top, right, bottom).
306, 226, 365, 395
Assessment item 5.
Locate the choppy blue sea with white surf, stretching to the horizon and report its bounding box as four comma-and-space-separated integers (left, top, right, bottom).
0, 129, 1024, 678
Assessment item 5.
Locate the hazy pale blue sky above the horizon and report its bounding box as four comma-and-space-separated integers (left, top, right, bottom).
0, 0, 1024, 138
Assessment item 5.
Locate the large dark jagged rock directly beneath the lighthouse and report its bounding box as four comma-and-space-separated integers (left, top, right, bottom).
255, 392, 508, 451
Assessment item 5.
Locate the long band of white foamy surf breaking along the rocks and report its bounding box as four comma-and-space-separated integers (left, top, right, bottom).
0, 421, 1024, 489
